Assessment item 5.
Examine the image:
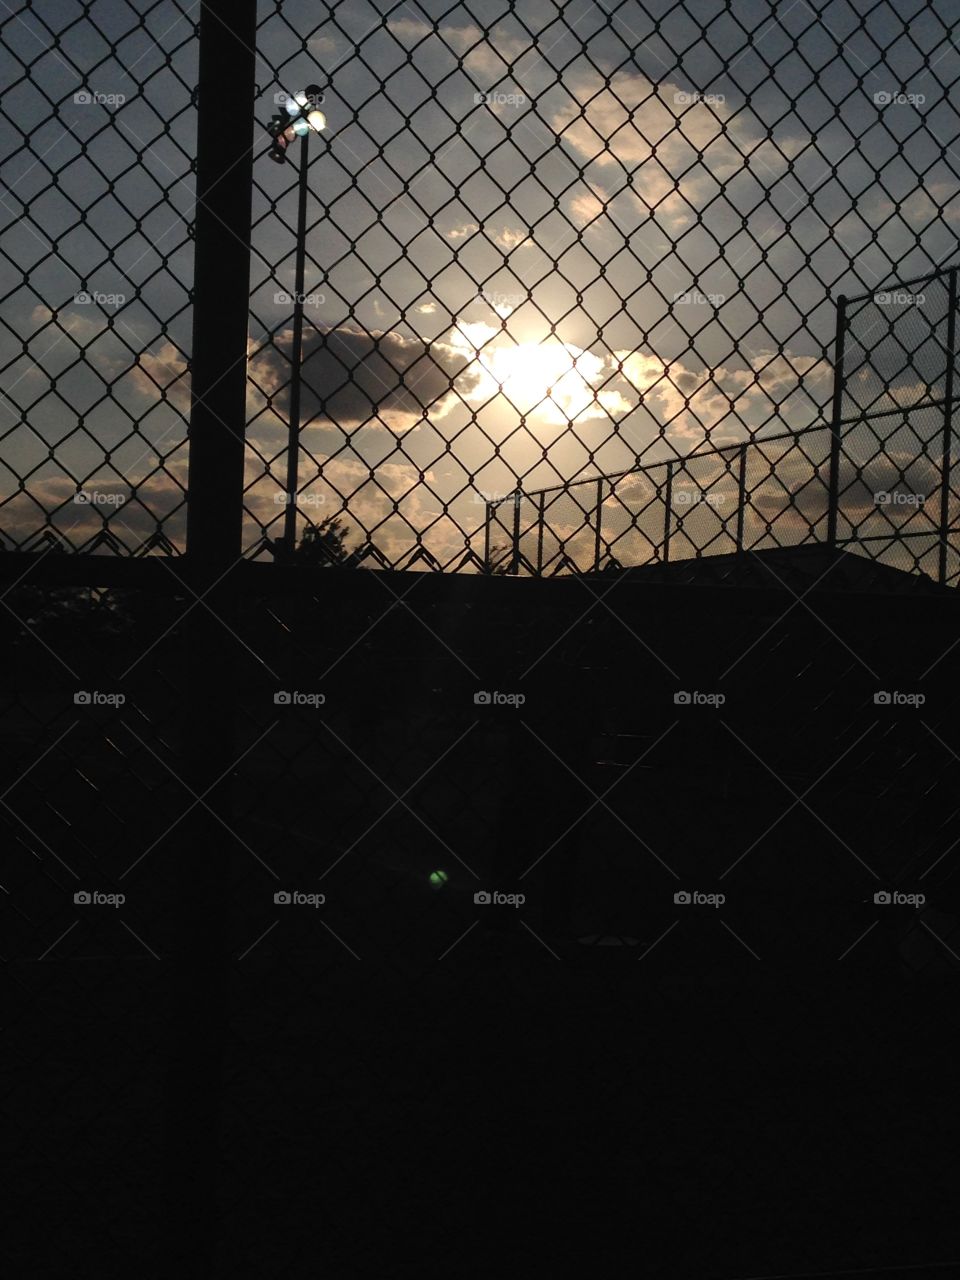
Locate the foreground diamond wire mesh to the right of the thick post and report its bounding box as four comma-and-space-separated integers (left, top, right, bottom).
241, 0, 960, 572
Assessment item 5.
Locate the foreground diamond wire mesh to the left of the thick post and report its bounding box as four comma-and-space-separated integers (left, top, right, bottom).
0, 0, 196, 554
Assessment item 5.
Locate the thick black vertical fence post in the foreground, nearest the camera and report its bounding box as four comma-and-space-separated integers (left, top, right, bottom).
171, 0, 257, 1280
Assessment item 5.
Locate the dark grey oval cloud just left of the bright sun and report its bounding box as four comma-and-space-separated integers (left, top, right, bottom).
252, 328, 477, 430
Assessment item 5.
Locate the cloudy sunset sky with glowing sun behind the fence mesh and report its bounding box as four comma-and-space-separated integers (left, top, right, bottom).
0, 0, 960, 563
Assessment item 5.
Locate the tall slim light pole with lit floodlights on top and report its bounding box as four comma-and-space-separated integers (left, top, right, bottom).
269, 84, 326, 561
